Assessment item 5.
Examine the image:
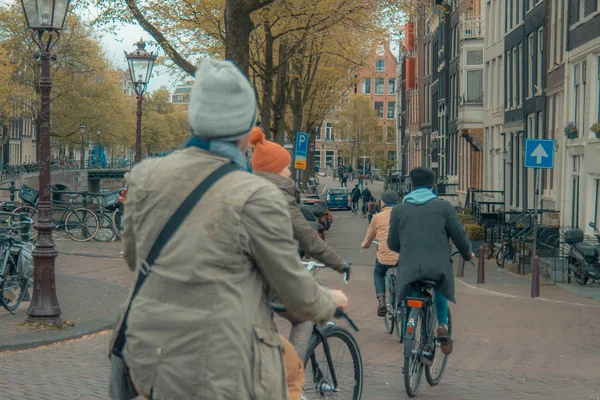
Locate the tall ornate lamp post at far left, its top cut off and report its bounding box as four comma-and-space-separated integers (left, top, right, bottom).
21, 0, 71, 323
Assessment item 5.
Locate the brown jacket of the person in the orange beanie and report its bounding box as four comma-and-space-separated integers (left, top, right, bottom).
256, 172, 346, 273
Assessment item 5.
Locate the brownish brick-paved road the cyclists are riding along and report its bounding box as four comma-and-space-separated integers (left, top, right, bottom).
0, 179, 600, 400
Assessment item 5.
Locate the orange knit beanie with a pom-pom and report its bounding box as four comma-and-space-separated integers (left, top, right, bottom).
250, 127, 292, 174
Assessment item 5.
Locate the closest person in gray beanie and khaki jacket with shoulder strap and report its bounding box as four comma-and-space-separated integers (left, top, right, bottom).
110, 59, 347, 400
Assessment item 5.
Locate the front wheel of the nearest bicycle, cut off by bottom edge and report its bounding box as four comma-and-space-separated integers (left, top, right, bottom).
304, 326, 363, 400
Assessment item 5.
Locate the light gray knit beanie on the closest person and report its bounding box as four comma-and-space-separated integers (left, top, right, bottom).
188, 58, 256, 141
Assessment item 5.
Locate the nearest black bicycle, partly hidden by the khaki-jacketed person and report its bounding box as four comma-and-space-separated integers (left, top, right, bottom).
271, 261, 364, 400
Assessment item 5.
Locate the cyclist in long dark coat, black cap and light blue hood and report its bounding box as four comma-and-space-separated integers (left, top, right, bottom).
387, 167, 475, 354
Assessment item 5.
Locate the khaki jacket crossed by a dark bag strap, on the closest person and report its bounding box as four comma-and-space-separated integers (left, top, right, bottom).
113, 148, 335, 400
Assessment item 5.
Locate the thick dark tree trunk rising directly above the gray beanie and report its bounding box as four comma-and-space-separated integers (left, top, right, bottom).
225, 0, 254, 76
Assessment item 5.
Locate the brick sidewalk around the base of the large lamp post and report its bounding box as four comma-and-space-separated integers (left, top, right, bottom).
0, 256, 131, 352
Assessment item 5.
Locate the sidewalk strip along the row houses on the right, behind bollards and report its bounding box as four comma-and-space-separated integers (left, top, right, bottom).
453, 256, 600, 306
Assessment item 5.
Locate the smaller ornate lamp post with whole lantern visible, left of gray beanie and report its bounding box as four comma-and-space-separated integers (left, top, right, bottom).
124, 39, 156, 163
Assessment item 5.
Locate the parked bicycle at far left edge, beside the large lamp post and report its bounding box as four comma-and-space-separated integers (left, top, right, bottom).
0, 212, 33, 314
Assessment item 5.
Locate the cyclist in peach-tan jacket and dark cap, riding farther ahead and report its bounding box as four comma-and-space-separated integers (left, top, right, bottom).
362, 190, 399, 317
